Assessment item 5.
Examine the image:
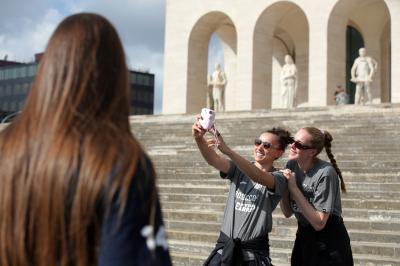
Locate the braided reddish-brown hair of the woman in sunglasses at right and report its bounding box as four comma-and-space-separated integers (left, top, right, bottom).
303, 127, 346, 192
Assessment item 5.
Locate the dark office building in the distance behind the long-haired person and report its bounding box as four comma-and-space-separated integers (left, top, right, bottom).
0, 54, 154, 120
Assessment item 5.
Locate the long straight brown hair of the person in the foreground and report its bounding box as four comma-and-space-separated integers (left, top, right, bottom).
0, 13, 148, 266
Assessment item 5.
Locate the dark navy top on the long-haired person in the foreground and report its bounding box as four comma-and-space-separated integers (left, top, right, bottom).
98, 155, 172, 266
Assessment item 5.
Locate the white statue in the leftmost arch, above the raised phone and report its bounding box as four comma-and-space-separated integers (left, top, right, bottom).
209, 63, 227, 112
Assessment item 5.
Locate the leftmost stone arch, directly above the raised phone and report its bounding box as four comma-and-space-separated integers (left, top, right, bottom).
186, 12, 237, 113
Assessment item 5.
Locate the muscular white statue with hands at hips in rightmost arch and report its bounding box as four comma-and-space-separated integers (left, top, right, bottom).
351, 48, 378, 104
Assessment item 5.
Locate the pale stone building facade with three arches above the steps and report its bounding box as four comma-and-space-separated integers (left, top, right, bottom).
163, 0, 400, 114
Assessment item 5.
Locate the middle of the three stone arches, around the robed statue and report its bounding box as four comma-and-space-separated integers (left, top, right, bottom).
252, 1, 309, 109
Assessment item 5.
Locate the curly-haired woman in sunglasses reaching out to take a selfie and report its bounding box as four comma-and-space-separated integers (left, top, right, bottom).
192, 117, 292, 265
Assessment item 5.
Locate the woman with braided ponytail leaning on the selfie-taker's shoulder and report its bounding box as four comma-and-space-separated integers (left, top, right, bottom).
280, 127, 353, 266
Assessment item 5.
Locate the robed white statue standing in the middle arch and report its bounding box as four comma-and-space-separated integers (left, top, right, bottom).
280, 55, 297, 108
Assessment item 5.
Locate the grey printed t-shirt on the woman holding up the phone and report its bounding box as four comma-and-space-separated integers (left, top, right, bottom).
220, 161, 287, 241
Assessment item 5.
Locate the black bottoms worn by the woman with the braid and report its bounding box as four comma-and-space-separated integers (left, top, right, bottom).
291, 215, 354, 266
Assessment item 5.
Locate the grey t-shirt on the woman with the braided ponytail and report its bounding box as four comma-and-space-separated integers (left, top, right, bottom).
286, 159, 342, 226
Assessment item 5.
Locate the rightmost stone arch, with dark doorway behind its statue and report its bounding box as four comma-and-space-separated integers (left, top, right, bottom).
327, 0, 391, 104
